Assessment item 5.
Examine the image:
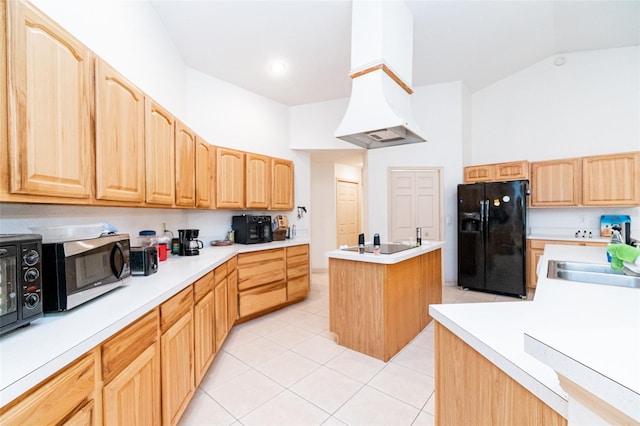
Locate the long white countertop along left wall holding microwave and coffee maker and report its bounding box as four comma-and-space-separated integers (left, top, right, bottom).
0, 239, 309, 406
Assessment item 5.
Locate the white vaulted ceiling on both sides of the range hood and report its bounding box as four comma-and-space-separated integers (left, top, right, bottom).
152, 0, 640, 105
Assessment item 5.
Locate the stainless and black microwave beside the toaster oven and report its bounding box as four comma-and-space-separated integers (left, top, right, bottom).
42, 234, 131, 312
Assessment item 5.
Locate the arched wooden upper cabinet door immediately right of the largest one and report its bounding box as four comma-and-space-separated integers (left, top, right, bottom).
96, 58, 145, 203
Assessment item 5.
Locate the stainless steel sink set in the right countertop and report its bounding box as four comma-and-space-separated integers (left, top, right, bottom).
547, 260, 640, 288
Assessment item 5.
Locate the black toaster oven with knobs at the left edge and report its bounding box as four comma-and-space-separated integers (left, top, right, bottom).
0, 234, 42, 335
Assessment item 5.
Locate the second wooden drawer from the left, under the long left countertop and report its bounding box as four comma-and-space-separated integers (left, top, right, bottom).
101, 309, 160, 383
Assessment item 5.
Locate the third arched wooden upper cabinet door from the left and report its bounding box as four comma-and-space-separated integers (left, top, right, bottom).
144, 98, 175, 206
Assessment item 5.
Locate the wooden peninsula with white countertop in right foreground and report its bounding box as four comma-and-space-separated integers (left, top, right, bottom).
431, 244, 640, 424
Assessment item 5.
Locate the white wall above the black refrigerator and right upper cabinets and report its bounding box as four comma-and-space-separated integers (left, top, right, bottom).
465, 46, 640, 161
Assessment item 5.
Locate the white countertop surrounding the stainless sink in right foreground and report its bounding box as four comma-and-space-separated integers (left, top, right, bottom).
430, 244, 640, 418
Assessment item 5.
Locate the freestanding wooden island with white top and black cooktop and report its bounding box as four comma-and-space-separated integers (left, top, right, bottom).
327, 241, 444, 362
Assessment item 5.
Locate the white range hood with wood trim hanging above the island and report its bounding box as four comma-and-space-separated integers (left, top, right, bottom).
335, 0, 425, 149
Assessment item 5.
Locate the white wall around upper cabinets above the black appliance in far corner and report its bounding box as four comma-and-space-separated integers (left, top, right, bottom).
182, 69, 311, 238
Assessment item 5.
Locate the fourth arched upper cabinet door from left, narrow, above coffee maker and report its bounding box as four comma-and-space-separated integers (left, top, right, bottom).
176, 121, 196, 207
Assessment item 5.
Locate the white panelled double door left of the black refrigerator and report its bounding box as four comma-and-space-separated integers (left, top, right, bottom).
389, 169, 442, 241
